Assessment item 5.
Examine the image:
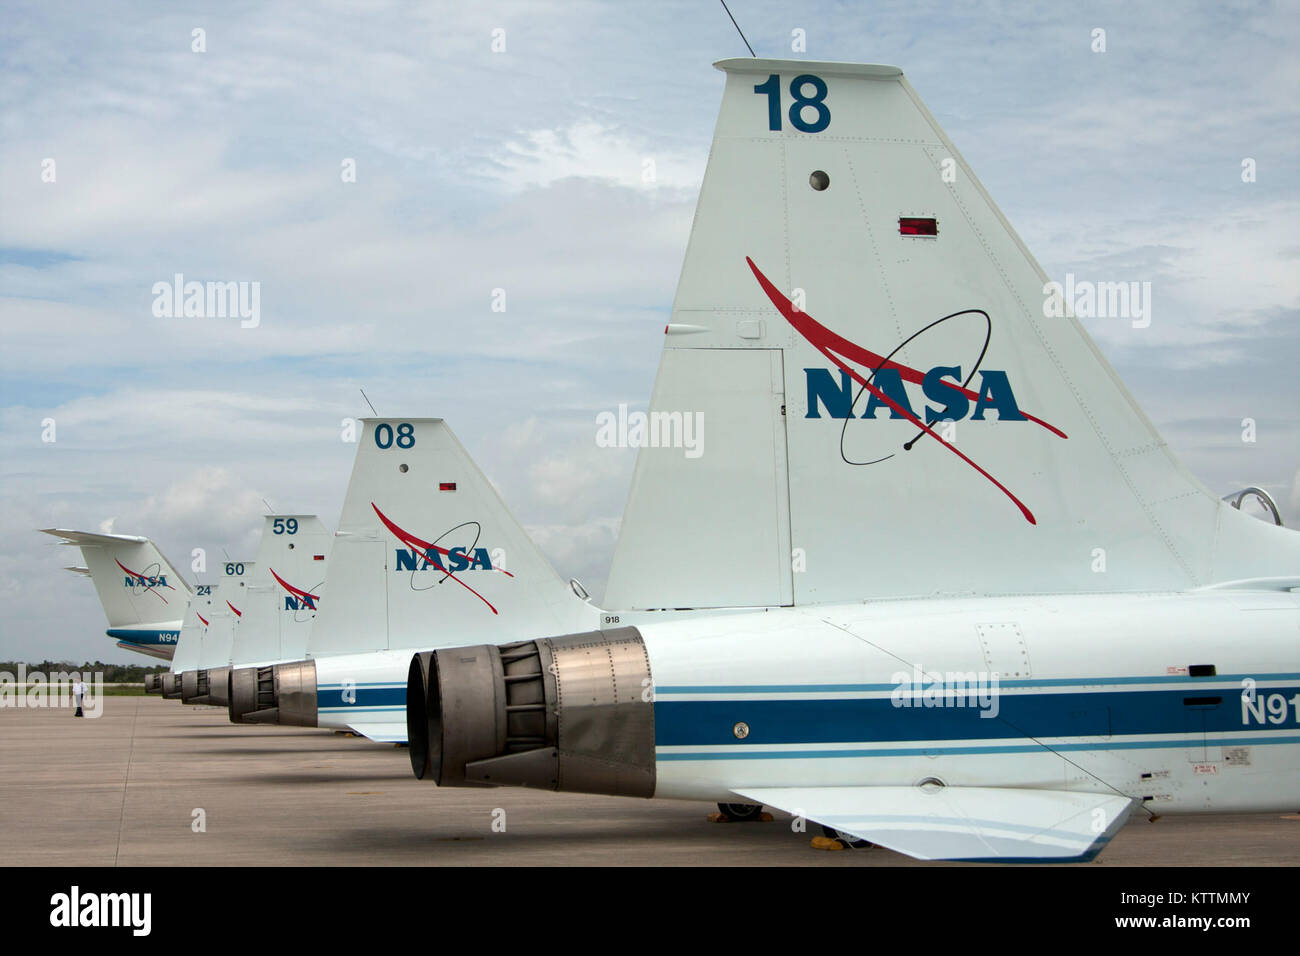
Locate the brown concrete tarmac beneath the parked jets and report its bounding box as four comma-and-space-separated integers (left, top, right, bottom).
0, 697, 1300, 866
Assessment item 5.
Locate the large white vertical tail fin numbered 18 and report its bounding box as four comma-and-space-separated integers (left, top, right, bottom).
605, 60, 1300, 609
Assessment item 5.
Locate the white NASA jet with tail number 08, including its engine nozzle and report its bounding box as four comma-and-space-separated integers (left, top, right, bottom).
231, 418, 599, 743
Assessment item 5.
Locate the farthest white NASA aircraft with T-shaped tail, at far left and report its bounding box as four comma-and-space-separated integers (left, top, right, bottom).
42, 528, 194, 661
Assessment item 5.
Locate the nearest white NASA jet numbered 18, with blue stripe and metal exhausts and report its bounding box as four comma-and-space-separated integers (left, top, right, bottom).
407, 59, 1300, 861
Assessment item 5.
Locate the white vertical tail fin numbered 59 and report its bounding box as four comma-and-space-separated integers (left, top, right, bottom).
228, 515, 334, 666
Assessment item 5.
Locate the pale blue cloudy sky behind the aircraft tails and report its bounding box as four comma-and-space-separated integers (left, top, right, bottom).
0, 0, 1300, 661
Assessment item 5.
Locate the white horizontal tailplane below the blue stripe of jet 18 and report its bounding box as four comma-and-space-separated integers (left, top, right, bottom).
735, 787, 1135, 862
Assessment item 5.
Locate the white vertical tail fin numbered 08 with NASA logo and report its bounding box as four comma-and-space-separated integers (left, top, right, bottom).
308, 418, 595, 658
